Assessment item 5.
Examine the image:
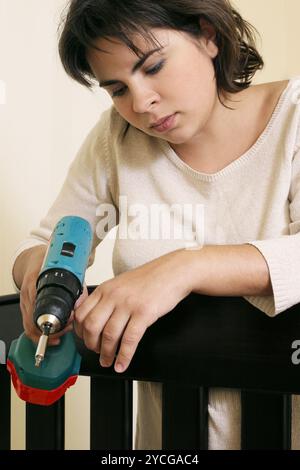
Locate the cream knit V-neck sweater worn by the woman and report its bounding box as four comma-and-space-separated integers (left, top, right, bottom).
15, 77, 300, 449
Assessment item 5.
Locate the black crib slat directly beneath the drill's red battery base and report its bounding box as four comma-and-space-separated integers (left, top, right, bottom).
26, 397, 65, 450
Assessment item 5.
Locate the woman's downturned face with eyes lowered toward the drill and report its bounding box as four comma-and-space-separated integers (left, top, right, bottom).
87, 29, 218, 144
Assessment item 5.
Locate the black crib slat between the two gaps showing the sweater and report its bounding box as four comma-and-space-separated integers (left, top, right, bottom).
162, 384, 208, 450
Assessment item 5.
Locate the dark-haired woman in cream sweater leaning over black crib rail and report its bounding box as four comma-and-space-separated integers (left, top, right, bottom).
13, 0, 300, 449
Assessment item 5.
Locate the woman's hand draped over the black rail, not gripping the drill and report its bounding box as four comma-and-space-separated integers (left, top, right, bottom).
75, 250, 192, 372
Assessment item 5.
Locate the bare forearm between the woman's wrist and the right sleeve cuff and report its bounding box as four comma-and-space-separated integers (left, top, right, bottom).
185, 244, 273, 297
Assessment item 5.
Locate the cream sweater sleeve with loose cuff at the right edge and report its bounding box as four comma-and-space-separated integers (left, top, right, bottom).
249, 148, 300, 316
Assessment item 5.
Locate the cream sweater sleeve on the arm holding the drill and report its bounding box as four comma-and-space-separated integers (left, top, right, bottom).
12, 110, 117, 291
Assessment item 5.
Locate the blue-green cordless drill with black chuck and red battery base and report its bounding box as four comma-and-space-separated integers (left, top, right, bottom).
7, 216, 92, 405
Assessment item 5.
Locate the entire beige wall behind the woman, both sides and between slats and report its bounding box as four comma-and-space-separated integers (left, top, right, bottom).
0, 0, 300, 449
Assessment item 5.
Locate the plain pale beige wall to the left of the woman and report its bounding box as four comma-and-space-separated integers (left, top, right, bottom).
0, 0, 112, 294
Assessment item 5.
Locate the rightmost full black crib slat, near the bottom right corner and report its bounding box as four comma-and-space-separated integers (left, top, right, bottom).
241, 392, 291, 450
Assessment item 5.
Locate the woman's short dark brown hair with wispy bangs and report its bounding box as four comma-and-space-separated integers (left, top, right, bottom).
59, 0, 264, 97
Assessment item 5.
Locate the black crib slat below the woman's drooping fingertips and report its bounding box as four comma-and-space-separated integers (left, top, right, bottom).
91, 377, 133, 450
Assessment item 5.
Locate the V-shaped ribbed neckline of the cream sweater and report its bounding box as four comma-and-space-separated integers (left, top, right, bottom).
160, 77, 300, 182
